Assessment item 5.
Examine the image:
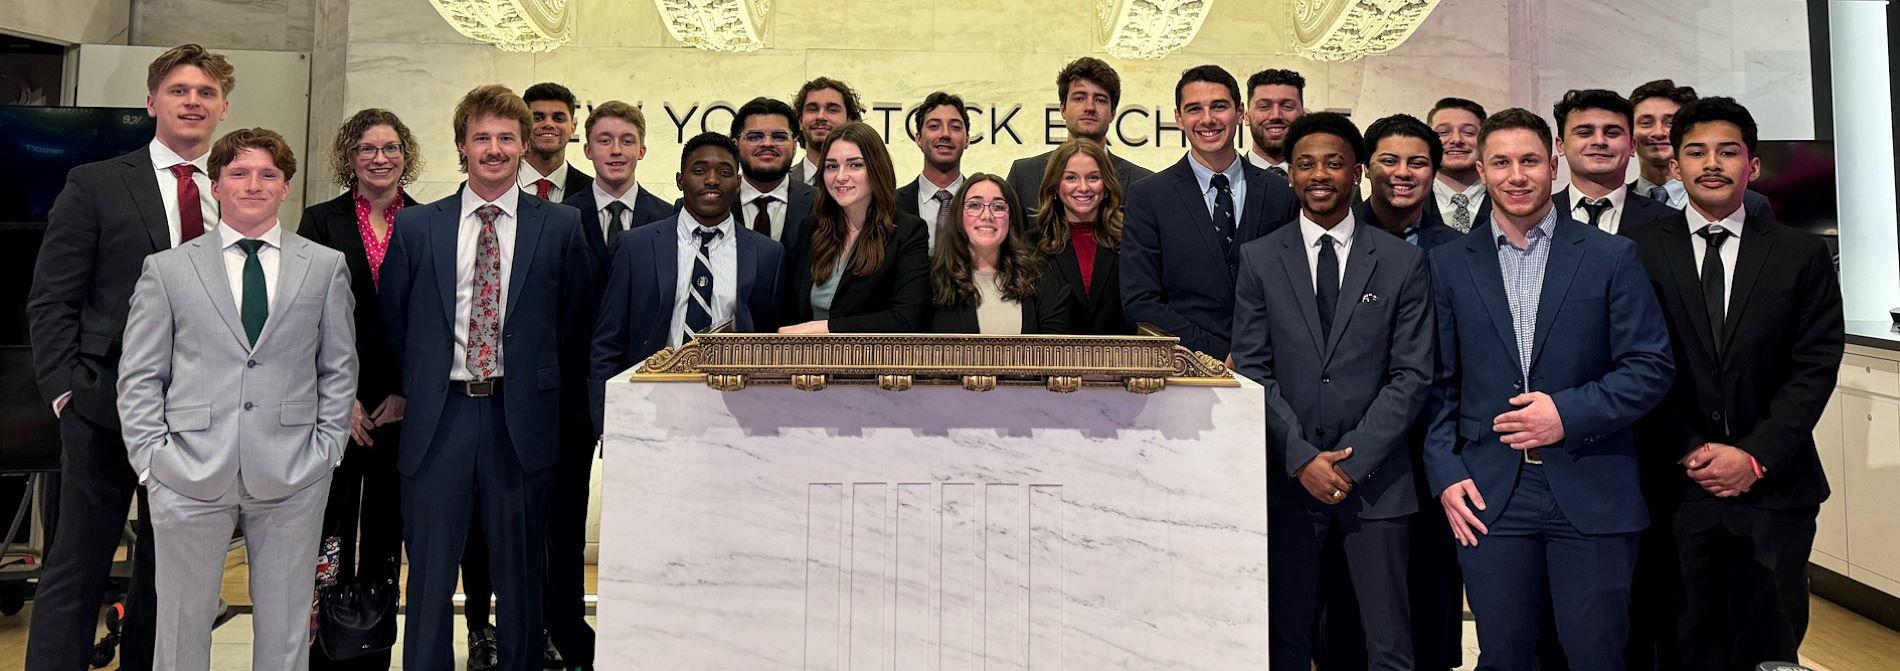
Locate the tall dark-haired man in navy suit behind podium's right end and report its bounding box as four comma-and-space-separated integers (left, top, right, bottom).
1121, 65, 1296, 359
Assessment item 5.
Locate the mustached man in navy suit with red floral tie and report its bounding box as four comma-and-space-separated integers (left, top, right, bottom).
378, 86, 595, 671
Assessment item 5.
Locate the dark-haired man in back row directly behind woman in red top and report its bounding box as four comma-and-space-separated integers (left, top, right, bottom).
1009, 55, 1153, 210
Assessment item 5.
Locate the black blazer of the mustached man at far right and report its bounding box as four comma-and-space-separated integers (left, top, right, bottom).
1630, 211, 1845, 508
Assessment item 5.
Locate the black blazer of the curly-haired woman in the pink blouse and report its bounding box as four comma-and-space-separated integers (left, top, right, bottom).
296, 192, 416, 409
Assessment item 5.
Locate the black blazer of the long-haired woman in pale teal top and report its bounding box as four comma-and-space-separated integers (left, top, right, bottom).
779, 215, 931, 333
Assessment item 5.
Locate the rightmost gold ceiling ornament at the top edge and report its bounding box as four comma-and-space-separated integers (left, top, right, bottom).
1294, 0, 1438, 61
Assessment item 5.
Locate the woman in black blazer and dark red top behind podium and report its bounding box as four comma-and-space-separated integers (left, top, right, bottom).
1036, 139, 1134, 335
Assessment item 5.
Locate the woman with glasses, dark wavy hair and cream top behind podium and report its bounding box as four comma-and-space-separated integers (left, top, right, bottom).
931, 173, 1070, 335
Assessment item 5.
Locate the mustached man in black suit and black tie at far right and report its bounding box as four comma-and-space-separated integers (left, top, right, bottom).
1632, 97, 1843, 669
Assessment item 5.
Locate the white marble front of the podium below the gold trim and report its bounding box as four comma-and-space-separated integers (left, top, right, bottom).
599, 380, 1267, 669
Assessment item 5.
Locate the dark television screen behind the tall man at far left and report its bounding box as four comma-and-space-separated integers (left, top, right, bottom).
0, 106, 158, 222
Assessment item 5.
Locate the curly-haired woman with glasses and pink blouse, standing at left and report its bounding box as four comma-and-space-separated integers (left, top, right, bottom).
296, 108, 422, 669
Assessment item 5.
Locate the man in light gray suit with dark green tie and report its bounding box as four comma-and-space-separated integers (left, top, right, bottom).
118, 129, 357, 671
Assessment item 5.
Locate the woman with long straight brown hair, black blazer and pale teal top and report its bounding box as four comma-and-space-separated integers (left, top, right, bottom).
779, 122, 931, 333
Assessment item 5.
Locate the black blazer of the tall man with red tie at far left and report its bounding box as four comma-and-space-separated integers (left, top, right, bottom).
27, 146, 171, 430
